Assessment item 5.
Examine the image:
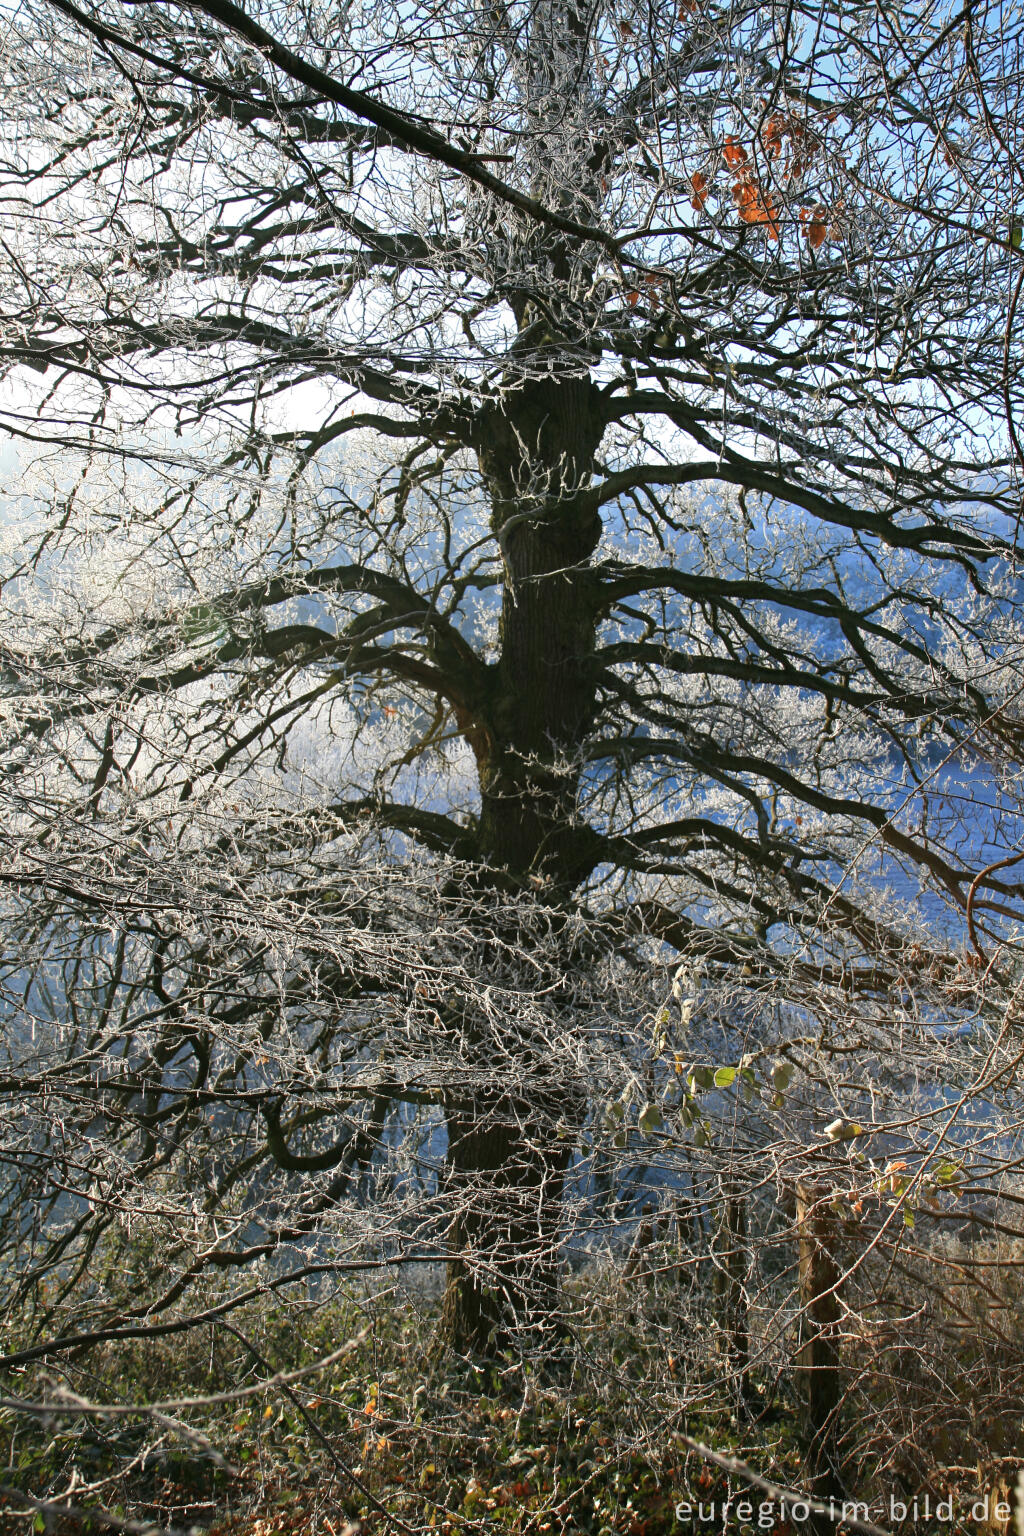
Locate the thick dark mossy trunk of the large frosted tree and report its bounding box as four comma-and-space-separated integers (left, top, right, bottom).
439, 372, 603, 1355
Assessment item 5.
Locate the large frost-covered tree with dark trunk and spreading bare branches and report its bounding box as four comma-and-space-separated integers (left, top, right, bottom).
3, 0, 1022, 1382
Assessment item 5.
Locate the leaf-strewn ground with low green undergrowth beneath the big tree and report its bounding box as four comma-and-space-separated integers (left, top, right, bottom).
0, 1271, 987, 1536
